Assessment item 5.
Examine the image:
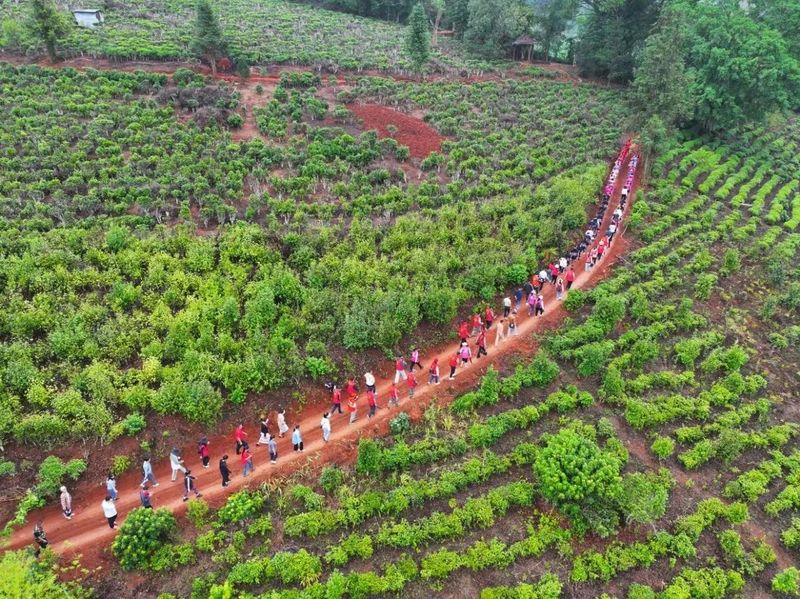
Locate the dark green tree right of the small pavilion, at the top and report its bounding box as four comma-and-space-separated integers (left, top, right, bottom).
576, 0, 660, 83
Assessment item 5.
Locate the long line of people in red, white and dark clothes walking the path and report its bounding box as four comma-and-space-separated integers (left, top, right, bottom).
33, 141, 639, 555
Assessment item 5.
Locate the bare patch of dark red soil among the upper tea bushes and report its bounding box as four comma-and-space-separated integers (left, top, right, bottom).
347, 104, 442, 158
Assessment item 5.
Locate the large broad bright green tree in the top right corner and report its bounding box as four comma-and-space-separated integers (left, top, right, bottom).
686, 0, 800, 131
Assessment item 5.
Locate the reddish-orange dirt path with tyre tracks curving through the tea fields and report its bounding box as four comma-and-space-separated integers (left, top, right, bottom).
0, 149, 633, 568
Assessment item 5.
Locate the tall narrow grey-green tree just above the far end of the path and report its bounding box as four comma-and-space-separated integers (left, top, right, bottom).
628, 2, 694, 130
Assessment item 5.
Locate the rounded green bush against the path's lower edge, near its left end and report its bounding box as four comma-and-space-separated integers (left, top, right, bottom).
111, 507, 177, 570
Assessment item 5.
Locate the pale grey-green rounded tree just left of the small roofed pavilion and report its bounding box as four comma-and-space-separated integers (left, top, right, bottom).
464, 0, 531, 58
